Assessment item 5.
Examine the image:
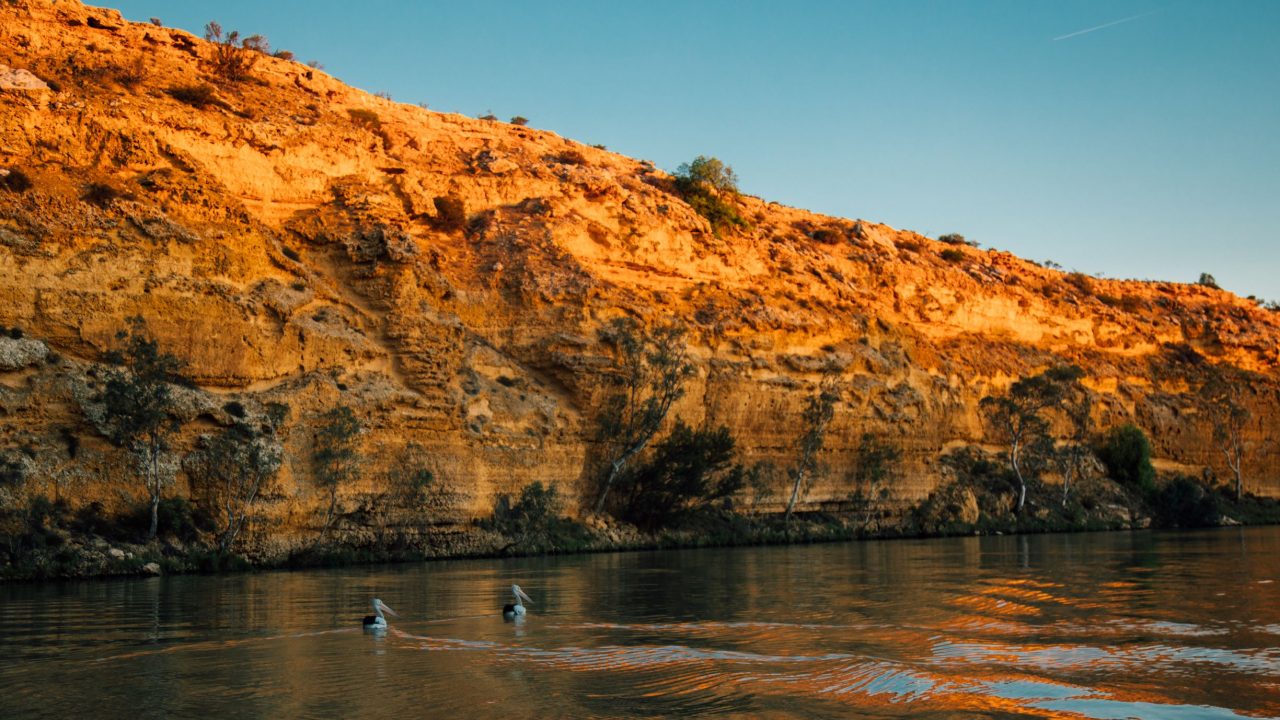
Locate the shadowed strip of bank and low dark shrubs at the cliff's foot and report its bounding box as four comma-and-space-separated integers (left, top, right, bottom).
0, 478, 1280, 580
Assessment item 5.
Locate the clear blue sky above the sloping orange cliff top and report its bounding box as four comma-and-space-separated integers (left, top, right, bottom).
118, 0, 1280, 300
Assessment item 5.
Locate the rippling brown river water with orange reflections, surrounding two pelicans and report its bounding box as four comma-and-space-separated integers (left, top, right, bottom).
0, 528, 1280, 719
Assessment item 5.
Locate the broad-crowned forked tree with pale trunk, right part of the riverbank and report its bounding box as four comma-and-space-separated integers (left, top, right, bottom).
979, 365, 1084, 512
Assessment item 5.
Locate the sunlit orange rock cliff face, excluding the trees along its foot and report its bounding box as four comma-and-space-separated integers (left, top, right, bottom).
0, 0, 1280, 543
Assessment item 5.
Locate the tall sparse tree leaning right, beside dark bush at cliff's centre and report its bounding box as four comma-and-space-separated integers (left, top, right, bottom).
595, 318, 694, 512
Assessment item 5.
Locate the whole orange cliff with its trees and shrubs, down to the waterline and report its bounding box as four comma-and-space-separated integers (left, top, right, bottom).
0, 0, 1280, 577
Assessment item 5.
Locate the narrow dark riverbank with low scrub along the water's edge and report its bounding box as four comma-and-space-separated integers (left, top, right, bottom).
0, 486, 1280, 582
